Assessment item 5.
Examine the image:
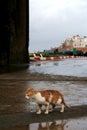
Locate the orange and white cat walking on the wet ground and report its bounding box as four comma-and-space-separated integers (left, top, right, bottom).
25, 88, 68, 114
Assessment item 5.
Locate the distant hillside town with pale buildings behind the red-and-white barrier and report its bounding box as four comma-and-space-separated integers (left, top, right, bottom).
29, 35, 87, 56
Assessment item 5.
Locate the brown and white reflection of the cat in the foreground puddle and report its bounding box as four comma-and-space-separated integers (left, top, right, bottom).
37, 120, 67, 130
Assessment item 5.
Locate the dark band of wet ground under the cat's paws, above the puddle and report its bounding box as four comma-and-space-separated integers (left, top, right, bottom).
0, 105, 87, 130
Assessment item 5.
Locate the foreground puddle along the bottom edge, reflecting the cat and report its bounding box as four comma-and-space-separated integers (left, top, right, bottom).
0, 117, 87, 130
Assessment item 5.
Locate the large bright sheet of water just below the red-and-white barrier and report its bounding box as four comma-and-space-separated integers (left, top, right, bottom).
29, 58, 87, 77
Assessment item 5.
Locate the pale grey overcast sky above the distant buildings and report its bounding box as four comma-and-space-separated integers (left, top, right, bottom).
29, 0, 87, 52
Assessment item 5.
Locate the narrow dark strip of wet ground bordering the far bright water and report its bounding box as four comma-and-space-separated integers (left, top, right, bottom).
0, 71, 87, 81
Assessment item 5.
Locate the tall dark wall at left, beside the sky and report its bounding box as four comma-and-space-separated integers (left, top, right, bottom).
0, 0, 29, 65
